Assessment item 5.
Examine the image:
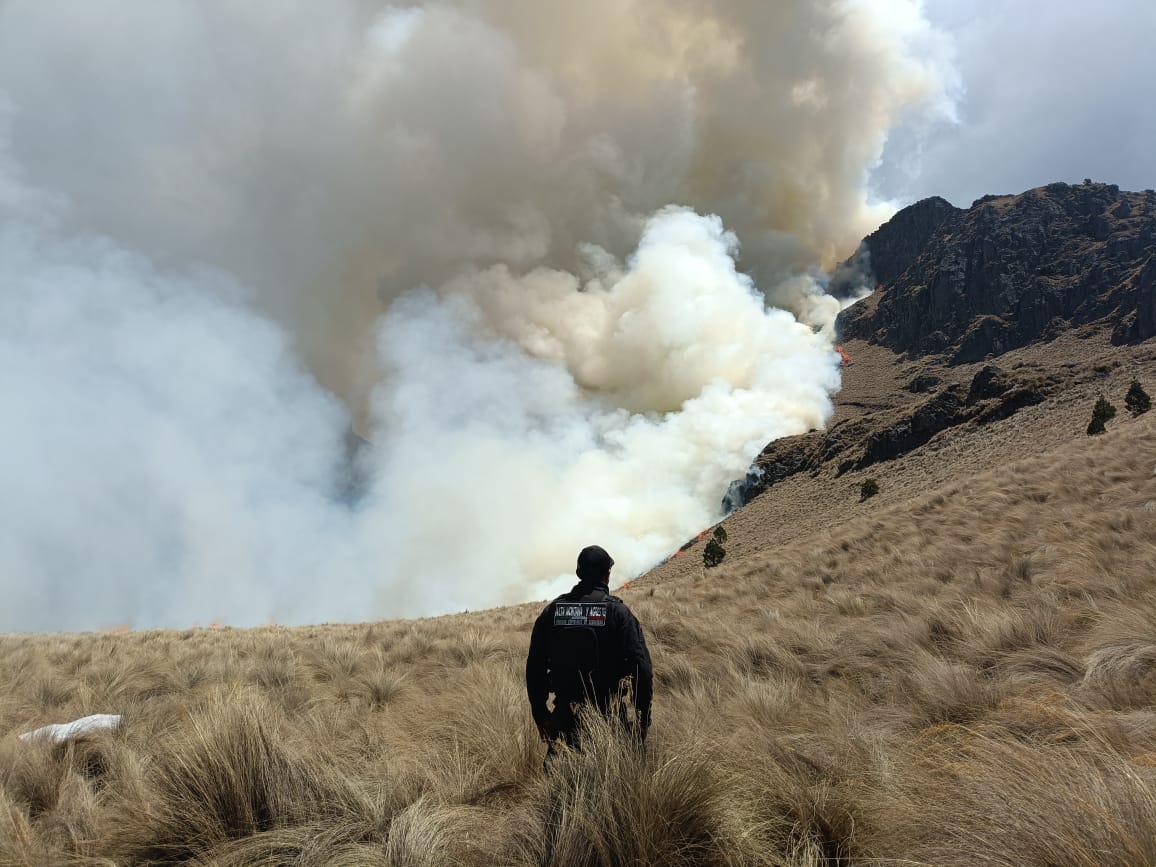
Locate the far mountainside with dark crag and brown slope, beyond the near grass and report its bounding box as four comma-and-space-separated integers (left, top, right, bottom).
675, 184, 1156, 572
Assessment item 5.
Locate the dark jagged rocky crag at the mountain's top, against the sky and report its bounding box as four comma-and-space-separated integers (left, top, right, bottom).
839, 184, 1156, 364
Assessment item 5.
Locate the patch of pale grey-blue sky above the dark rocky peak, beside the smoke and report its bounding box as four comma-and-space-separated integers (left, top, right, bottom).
873, 0, 1156, 207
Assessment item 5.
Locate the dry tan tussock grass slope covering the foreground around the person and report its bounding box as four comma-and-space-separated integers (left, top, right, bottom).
0, 335, 1156, 867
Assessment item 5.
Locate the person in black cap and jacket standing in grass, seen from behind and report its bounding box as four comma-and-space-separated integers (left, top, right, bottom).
526, 544, 654, 755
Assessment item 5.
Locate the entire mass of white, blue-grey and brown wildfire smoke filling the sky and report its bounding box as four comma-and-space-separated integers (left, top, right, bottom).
0, 0, 943, 629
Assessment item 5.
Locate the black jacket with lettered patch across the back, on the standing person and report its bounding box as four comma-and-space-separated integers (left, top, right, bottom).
526, 581, 654, 728
